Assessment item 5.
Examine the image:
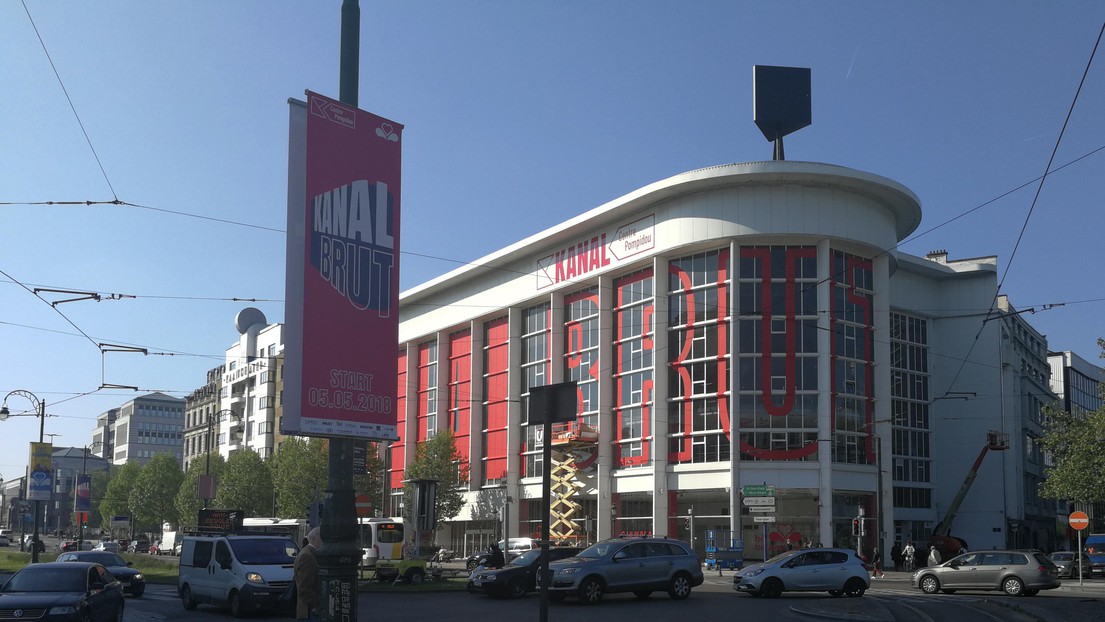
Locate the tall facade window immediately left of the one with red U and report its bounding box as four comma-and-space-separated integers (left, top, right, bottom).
667, 250, 732, 463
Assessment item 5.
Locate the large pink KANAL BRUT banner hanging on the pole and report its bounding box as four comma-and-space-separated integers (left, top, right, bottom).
281, 92, 402, 440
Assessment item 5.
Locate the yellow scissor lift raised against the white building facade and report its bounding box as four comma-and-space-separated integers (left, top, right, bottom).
549, 421, 599, 545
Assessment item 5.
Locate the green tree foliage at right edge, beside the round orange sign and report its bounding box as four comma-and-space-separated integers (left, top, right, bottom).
1039, 402, 1105, 503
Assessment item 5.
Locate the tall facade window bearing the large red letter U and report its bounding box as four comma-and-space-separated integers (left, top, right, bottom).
737, 246, 819, 461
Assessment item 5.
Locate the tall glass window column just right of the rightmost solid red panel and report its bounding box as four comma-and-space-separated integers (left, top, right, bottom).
520, 304, 551, 477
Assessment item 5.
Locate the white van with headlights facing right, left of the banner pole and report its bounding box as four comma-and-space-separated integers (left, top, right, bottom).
177, 536, 299, 618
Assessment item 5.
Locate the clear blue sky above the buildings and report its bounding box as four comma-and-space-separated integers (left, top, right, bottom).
0, 0, 1105, 478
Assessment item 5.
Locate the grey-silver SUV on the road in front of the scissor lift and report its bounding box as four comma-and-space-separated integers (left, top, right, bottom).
549, 538, 703, 604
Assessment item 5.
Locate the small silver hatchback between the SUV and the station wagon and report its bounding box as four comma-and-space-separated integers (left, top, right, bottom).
733, 549, 871, 598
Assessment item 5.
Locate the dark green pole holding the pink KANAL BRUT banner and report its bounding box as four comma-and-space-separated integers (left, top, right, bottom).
316, 0, 361, 622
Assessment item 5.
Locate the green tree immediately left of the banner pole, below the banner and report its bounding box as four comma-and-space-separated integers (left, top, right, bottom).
270, 436, 327, 518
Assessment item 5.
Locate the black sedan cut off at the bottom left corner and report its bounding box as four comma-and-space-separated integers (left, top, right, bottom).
0, 561, 125, 622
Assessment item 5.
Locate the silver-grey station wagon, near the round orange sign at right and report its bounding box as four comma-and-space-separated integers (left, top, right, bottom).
912, 550, 1060, 597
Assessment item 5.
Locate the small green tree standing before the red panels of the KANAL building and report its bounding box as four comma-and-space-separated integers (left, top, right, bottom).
403, 428, 469, 530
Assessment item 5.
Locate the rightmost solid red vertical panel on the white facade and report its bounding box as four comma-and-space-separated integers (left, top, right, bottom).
484, 317, 511, 479
